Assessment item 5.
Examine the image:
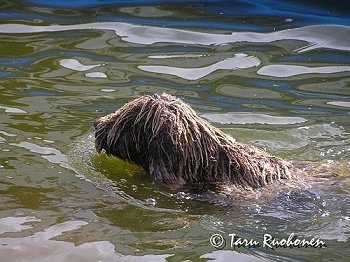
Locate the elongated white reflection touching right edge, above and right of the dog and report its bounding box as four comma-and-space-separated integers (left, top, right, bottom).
257, 64, 350, 77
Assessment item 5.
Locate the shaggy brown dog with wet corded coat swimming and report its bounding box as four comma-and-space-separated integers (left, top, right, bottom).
94, 94, 294, 188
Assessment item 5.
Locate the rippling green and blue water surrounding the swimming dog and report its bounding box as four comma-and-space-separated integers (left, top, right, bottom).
0, 1, 350, 261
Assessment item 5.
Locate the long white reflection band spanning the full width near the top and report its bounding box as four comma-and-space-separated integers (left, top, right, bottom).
0, 22, 350, 52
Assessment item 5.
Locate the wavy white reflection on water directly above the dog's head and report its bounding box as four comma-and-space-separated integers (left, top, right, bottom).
138, 54, 260, 80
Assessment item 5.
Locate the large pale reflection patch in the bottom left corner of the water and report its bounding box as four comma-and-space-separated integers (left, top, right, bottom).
0, 217, 171, 262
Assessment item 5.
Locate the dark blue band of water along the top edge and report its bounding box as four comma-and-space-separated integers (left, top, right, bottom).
4, 0, 350, 28
